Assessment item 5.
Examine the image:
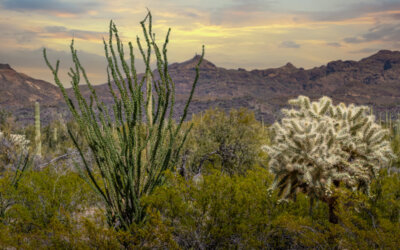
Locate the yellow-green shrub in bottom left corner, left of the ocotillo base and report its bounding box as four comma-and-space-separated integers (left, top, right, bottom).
0, 166, 99, 249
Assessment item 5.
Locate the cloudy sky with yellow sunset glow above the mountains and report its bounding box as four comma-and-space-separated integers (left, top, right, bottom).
0, 0, 400, 86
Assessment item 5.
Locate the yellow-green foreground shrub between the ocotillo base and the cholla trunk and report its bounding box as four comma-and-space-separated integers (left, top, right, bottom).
145, 168, 276, 249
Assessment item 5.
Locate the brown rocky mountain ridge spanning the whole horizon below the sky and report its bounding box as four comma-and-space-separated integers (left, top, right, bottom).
0, 50, 400, 126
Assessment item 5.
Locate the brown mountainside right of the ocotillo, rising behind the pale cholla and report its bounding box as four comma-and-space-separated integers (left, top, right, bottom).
141, 50, 400, 122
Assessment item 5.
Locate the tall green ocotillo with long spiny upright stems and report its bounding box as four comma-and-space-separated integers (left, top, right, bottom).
43, 12, 204, 230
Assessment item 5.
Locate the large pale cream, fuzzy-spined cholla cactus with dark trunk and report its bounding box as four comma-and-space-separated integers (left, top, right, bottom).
266, 96, 394, 223
